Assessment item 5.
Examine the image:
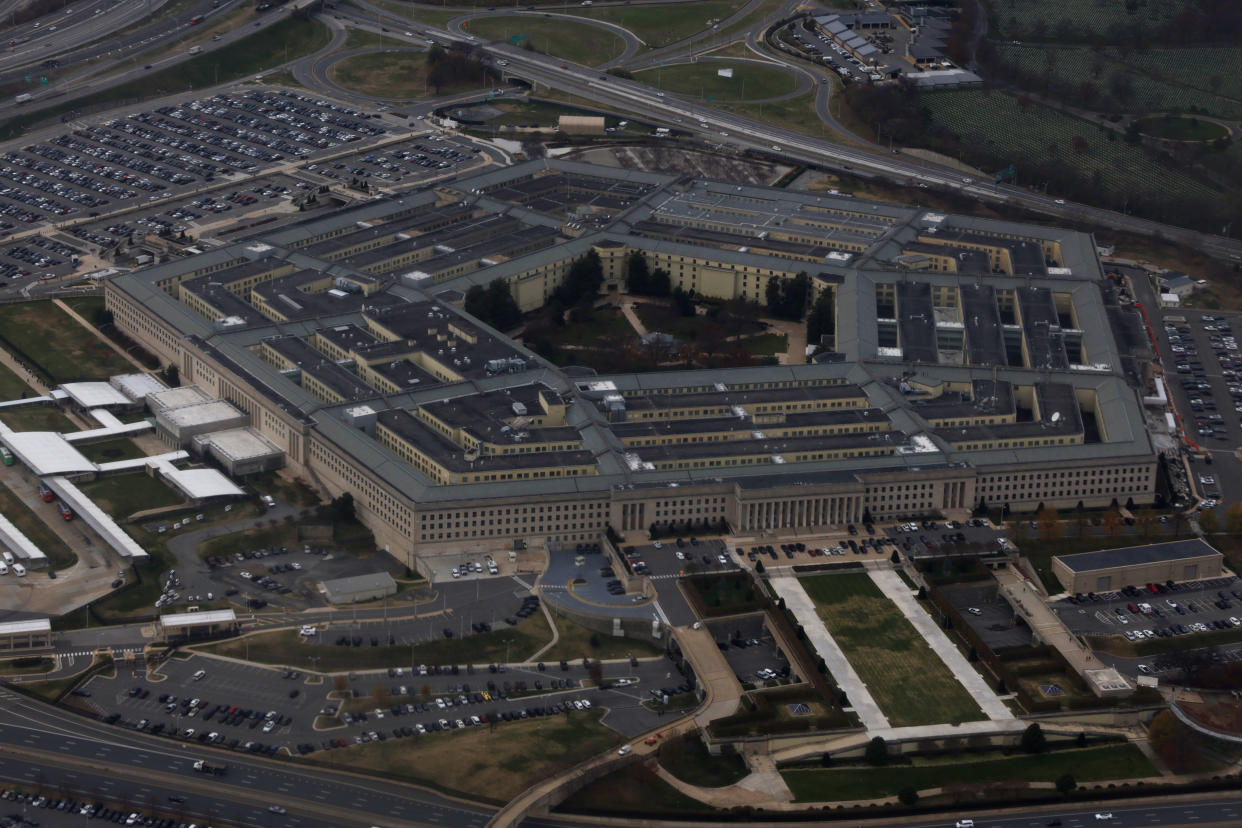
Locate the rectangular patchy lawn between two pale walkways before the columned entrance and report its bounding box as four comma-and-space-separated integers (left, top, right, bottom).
801, 575, 982, 727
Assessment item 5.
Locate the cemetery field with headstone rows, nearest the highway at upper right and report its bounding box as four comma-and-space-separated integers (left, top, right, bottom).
922, 91, 1220, 207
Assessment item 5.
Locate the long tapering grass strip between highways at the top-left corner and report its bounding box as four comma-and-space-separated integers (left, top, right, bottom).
0, 17, 332, 140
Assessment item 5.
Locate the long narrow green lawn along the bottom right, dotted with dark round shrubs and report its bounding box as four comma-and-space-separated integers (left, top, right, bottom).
781, 745, 1158, 802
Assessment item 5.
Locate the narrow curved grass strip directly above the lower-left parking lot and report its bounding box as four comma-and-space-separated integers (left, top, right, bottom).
202, 612, 551, 673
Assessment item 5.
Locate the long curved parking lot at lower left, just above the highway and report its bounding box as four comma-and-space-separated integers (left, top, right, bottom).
76, 657, 679, 755
